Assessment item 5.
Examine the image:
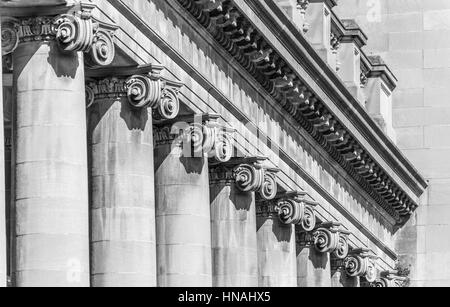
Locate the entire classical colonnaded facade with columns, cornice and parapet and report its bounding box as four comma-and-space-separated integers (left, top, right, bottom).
0, 0, 427, 287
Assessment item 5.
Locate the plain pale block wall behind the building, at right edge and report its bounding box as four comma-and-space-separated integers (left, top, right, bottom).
336, 0, 450, 286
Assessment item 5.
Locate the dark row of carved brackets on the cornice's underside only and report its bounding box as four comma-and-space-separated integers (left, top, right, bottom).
178, 0, 418, 225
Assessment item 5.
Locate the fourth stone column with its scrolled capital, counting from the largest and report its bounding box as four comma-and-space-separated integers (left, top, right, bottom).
210, 158, 265, 287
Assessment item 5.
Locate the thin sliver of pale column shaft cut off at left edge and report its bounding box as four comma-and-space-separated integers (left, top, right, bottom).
0, 16, 7, 287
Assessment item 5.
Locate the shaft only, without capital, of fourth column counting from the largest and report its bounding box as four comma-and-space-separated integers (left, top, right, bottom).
211, 183, 258, 287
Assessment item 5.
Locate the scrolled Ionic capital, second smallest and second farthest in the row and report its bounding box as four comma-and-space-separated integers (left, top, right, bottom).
344, 248, 378, 283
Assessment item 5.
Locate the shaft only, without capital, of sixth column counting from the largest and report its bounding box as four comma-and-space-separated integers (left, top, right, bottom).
297, 245, 331, 288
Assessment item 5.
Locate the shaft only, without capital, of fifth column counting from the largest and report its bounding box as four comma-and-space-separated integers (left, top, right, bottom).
257, 216, 297, 287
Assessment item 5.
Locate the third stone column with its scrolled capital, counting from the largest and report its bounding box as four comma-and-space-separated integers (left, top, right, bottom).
154, 115, 233, 287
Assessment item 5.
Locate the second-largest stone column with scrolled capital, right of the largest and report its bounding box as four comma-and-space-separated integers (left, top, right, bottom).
86, 66, 180, 287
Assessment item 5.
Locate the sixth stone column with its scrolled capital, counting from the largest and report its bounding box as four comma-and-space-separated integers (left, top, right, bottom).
297, 222, 348, 287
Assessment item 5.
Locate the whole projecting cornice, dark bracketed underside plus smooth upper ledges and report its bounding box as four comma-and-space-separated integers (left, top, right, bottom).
174, 0, 426, 226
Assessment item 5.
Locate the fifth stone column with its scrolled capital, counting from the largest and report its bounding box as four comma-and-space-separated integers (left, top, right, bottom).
257, 191, 315, 287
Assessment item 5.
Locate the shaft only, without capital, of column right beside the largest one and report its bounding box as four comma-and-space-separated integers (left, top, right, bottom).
89, 93, 156, 287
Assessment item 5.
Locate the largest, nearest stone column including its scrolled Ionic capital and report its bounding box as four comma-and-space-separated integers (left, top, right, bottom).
2, 7, 114, 286
